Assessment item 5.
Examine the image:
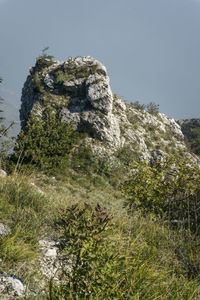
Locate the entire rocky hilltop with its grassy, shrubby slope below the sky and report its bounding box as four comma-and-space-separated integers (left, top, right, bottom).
0, 54, 200, 300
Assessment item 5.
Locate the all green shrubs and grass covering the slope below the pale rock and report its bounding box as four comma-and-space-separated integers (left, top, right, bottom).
0, 64, 200, 300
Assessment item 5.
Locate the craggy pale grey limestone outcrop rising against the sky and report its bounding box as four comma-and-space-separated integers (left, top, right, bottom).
20, 56, 189, 160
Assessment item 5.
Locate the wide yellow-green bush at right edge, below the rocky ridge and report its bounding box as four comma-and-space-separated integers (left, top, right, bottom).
122, 158, 200, 233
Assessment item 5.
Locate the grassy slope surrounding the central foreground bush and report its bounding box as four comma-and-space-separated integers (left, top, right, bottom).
0, 164, 200, 300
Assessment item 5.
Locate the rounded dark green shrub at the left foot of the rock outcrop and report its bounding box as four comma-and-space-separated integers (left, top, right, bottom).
13, 107, 77, 170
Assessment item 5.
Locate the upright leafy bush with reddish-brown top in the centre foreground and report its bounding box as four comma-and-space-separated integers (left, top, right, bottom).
50, 203, 125, 299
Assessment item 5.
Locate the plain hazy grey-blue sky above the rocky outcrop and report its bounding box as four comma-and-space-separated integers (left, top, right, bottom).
0, 0, 200, 131
